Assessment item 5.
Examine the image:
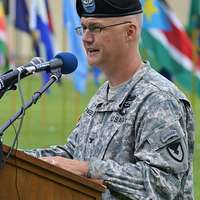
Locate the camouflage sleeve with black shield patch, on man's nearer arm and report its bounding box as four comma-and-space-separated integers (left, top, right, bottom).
88, 94, 192, 200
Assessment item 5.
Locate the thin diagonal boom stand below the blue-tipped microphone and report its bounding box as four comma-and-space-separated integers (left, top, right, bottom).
0, 70, 62, 168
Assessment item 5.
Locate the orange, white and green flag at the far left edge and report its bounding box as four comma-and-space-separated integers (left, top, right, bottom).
0, 0, 7, 66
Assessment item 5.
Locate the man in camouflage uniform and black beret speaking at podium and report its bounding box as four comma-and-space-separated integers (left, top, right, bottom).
27, 0, 194, 200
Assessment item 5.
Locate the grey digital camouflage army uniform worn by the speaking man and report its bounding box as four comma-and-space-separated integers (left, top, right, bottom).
25, 63, 194, 200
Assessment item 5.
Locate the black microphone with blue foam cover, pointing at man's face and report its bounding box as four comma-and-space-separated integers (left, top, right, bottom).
0, 52, 78, 91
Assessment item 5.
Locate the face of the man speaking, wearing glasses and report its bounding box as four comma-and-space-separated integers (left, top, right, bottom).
81, 18, 125, 69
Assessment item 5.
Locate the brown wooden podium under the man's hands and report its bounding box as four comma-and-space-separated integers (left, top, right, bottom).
0, 145, 106, 200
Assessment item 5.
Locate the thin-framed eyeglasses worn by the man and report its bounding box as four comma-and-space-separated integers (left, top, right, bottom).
75, 21, 132, 36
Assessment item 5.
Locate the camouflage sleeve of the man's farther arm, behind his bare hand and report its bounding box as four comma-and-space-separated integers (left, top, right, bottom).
24, 123, 79, 158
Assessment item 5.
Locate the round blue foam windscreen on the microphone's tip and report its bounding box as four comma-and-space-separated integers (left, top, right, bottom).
55, 52, 78, 74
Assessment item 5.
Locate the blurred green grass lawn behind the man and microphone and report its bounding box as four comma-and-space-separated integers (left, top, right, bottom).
0, 76, 200, 199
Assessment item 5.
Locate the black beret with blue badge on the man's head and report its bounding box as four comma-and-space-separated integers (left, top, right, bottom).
76, 0, 142, 17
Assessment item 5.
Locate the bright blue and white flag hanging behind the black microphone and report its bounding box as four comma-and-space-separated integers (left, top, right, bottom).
30, 0, 55, 87
